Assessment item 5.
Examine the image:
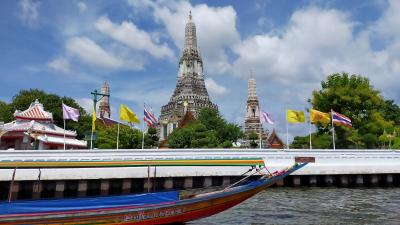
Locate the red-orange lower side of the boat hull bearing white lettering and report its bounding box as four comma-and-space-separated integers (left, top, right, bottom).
1, 183, 272, 225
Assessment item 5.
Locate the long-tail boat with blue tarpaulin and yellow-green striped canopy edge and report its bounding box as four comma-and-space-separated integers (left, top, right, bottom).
0, 158, 307, 225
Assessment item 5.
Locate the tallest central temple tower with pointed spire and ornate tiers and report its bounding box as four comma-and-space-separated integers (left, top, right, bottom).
159, 12, 218, 140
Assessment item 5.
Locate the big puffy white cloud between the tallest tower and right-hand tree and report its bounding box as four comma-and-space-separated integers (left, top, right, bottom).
233, 8, 354, 83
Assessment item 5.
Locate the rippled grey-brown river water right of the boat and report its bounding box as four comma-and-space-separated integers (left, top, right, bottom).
188, 188, 400, 225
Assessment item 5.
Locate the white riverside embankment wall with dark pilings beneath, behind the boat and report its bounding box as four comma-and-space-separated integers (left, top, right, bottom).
0, 149, 400, 200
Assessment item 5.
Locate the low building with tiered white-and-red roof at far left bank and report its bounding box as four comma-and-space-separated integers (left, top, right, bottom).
0, 100, 87, 150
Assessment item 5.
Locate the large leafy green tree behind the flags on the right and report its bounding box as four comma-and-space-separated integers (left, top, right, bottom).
294, 73, 400, 148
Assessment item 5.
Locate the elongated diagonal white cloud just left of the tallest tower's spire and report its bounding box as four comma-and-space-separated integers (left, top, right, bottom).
95, 16, 174, 58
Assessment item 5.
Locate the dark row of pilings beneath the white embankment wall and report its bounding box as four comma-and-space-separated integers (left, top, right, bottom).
0, 174, 400, 200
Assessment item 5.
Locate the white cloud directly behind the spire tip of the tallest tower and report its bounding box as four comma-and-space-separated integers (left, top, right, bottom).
141, 1, 240, 74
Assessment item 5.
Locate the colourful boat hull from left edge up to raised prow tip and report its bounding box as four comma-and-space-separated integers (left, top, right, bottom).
0, 164, 305, 225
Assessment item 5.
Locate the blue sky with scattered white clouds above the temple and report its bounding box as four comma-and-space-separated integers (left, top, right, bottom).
0, 0, 400, 140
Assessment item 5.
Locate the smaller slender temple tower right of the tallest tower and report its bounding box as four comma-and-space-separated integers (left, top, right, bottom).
244, 77, 263, 134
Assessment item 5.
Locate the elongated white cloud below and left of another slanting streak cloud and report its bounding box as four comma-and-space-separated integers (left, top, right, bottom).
66, 37, 143, 69
